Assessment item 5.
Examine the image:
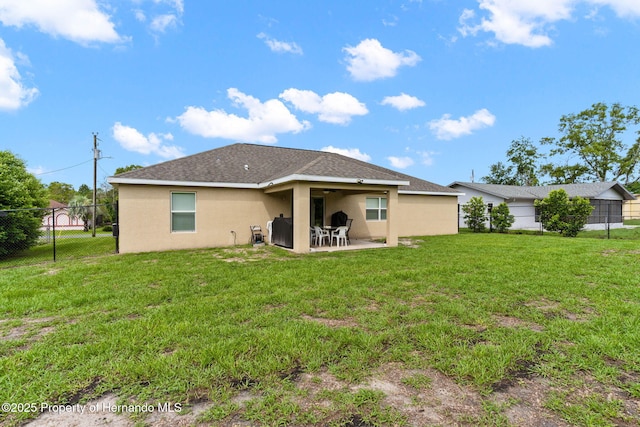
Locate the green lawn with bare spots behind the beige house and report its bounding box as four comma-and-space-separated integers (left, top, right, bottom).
0, 233, 640, 426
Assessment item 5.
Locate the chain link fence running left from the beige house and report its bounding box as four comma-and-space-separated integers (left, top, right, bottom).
0, 204, 118, 269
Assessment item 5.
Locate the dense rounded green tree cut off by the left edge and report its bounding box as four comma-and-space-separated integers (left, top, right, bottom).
0, 151, 48, 257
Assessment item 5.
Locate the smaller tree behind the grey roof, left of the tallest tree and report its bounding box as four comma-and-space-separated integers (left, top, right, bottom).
482, 136, 541, 185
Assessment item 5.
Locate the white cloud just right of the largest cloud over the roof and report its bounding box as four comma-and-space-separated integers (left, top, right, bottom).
279, 88, 369, 125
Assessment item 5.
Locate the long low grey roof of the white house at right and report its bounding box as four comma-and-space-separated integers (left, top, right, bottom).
449, 181, 634, 200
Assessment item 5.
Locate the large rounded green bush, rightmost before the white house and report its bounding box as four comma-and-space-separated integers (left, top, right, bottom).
534, 189, 593, 237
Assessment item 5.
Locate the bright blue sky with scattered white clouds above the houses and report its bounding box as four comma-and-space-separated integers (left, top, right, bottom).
0, 0, 640, 188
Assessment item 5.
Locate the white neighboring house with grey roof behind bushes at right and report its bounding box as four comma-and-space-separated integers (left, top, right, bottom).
449, 182, 635, 230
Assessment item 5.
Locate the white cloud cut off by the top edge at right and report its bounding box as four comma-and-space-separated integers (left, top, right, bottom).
458, 0, 640, 48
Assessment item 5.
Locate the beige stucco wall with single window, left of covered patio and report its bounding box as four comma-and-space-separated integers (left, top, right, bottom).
118, 185, 291, 253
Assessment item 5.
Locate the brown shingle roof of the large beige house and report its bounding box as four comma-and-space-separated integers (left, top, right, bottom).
109, 143, 457, 195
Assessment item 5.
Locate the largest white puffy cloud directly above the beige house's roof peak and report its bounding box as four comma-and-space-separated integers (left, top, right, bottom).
176, 88, 311, 144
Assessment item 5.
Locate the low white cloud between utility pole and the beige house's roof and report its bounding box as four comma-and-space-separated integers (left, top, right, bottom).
112, 122, 184, 159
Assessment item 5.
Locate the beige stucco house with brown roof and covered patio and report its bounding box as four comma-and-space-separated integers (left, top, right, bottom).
108, 144, 459, 253
